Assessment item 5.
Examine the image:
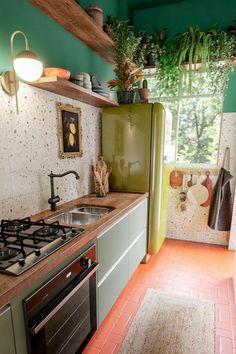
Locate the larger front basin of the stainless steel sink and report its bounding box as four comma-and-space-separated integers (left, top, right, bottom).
48, 211, 100, 225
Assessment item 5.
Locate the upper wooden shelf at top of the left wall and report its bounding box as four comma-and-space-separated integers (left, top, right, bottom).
29, 0, 115, 64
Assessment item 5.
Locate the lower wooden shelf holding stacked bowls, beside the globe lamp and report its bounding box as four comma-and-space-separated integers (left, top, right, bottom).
27, 76, 118, 107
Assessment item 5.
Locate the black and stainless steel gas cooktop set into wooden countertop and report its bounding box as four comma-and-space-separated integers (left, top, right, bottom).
0, 218, 84, 275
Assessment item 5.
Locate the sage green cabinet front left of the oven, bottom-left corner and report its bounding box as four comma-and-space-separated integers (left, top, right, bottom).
0, 306, 15, 354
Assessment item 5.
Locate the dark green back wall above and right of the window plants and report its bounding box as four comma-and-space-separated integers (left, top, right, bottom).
133, 0, 236, 112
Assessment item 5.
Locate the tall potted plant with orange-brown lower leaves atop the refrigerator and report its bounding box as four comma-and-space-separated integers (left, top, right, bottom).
108, 16, 142, 104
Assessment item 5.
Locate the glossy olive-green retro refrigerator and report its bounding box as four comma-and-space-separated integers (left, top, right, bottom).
102, 103, 169, 254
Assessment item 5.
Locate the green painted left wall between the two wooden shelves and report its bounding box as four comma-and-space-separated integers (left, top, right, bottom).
0, 0, 118, 84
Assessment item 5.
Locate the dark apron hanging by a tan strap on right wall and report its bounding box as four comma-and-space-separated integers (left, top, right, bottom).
208, 147, 233, 231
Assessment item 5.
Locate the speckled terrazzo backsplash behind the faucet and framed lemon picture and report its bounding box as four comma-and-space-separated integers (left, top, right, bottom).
0, 84, 101, 219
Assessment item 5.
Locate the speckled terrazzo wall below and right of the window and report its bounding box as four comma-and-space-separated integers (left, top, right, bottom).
167, 113, 236, 250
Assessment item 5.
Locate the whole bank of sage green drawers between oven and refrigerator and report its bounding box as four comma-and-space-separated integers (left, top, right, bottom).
97, 199, 147, 324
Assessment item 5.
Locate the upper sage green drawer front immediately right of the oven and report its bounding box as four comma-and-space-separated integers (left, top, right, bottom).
97, 216, 129, 281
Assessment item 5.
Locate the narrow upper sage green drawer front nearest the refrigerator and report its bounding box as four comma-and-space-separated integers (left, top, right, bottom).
129, 199, 147, 244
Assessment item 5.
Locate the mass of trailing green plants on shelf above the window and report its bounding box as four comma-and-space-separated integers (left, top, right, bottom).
157, 26, 236, 93
